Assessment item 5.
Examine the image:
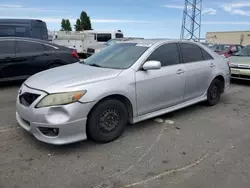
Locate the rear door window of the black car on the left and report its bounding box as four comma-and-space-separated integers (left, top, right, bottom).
18, 41, 44, 53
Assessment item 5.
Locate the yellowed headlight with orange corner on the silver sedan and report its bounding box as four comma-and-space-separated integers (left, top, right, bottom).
36, 91, 87, 108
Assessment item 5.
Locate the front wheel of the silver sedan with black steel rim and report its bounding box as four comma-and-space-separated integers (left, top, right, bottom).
87, 99, 128, 143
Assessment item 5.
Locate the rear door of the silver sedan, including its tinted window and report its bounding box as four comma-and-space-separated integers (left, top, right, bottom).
179, 43, 213, 101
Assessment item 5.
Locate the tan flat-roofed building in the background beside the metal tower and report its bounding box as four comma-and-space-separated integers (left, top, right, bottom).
206, 31, 250, 46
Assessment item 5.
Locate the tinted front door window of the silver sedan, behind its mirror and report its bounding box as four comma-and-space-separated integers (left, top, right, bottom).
147, 43, 180, 66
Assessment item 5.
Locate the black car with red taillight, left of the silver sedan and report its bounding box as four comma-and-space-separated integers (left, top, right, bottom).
0, 37, 79, 82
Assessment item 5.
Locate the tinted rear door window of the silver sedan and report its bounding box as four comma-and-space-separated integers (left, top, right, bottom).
180, 43, 203, 63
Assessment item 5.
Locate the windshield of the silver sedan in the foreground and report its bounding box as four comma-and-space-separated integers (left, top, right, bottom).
82, 43, 148, 69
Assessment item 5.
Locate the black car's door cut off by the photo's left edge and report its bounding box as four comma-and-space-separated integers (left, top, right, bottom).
0, 39, 19, 80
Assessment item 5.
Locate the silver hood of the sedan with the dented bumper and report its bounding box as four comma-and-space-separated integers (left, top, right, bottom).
25, 63, 122, 93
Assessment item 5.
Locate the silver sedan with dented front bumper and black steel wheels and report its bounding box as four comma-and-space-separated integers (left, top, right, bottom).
16, 40, 230, 145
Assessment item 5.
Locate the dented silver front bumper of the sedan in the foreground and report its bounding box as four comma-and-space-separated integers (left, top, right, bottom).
16, 86, 94, 145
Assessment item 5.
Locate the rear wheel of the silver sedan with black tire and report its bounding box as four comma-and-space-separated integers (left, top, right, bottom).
207, 79, 223, 106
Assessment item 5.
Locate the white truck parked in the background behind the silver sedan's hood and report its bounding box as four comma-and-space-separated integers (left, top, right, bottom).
52, 30, 123, 54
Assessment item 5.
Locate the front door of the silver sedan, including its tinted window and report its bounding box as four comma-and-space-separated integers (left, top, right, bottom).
136, 43, 185, 116
